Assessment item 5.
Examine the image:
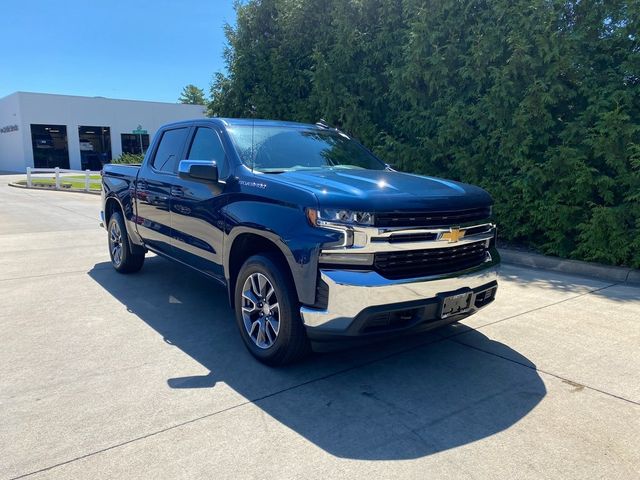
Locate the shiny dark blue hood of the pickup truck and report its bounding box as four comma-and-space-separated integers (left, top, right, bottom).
262, 170, 493, 212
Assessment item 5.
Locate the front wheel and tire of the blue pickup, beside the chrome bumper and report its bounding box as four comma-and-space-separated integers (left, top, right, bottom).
235, 254, 310, 366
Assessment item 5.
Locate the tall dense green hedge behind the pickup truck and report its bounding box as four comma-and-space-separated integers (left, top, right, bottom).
209, 0, 640, 267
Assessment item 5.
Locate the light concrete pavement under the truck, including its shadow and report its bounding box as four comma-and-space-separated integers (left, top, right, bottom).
0, 176, 640, 479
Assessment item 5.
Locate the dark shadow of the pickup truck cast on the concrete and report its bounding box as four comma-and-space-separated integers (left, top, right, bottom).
89, 257, 546, 460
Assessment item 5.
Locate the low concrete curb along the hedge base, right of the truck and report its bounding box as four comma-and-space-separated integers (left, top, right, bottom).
498, 248, 640, 284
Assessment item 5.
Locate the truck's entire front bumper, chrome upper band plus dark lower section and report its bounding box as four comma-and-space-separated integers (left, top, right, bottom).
300, 248, 500, 340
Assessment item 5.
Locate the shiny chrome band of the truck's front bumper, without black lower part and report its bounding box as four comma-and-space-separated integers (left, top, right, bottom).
300, 253, 500, 334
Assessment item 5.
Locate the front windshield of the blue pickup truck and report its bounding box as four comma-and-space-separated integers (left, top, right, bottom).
227, 125, 386, 173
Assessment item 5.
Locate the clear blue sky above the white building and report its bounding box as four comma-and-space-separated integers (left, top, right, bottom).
0, 0, 235, 102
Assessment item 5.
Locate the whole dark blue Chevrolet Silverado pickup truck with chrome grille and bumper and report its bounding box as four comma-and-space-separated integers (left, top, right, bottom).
102, 118, 500, 365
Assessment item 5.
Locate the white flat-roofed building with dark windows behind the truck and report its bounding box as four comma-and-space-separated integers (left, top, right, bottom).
0, 92, 205, 172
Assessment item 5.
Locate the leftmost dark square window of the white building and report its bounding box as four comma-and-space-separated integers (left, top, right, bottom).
31, 123, 69, 168
